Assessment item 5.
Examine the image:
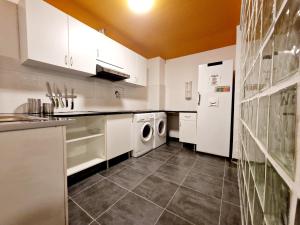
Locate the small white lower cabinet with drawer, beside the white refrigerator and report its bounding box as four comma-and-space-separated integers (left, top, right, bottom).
179, 113, 197, 144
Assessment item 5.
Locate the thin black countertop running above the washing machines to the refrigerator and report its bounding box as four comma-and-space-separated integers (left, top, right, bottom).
53, 110, 197, 117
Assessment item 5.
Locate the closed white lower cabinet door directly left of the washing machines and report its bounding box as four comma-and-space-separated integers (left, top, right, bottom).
106, 114, 132, 160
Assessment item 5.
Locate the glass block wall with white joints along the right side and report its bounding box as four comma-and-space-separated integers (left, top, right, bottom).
238, 0, 300, 225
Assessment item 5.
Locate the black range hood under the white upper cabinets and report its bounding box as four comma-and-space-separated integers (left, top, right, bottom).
92, 63, 130, 81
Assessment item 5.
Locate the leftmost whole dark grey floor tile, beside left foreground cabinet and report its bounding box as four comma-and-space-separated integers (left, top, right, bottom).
73, 179, 127, 217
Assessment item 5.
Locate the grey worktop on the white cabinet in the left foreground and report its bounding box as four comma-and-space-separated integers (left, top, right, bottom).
0, 114, 74, 132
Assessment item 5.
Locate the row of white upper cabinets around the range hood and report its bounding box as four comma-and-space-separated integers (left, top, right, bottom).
19, 0, 147, 81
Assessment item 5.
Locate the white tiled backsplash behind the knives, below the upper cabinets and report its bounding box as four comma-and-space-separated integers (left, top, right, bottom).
0, 56, 148, 113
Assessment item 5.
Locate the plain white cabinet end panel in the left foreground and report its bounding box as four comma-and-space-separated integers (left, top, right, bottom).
0, 127, 68, 225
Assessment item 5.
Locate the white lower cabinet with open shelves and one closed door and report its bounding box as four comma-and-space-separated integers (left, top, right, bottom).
66, 114, 132, 176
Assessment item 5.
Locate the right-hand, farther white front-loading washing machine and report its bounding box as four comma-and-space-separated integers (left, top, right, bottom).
153, 112, 167, 148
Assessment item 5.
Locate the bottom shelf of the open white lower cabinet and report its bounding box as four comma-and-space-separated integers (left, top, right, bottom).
67, 156, 105, 176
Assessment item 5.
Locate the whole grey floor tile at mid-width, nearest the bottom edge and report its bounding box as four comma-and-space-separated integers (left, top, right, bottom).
133, 175, 178, 207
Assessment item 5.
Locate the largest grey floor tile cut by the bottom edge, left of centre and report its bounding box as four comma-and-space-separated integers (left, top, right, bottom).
97, 193, 163, 225
